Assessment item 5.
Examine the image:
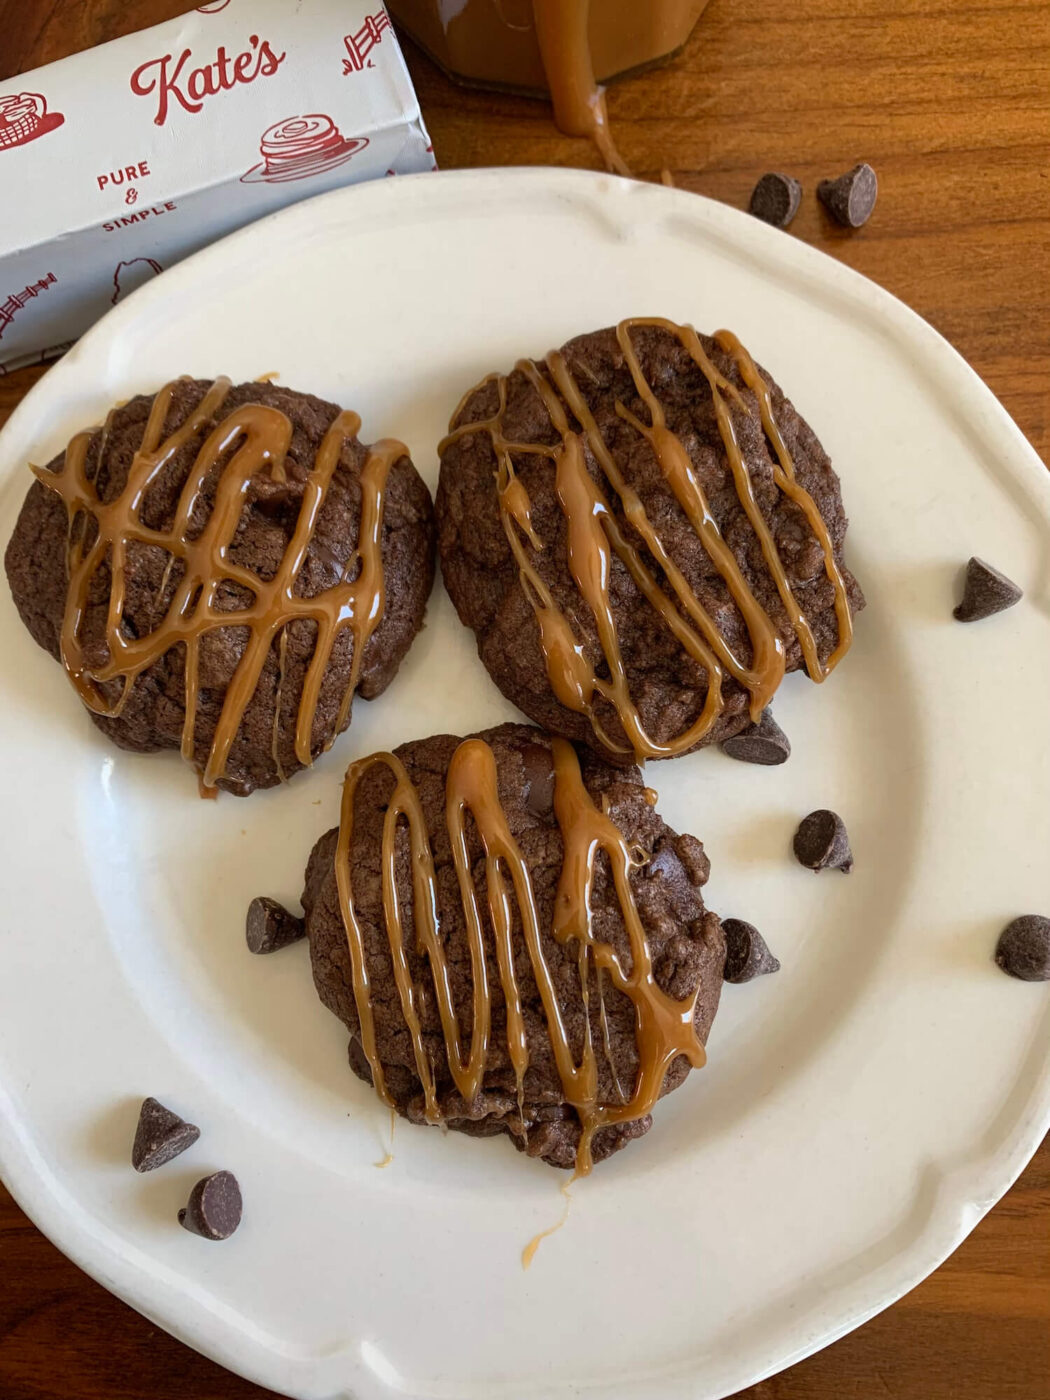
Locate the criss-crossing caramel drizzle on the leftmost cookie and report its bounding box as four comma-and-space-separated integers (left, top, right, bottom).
34, 378, 407, 788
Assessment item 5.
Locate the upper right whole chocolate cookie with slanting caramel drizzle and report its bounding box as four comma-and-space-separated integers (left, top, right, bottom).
437, 319, 864, 763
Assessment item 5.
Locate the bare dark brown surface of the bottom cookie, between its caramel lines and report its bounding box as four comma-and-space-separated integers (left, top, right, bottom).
302, 724, 725, 1168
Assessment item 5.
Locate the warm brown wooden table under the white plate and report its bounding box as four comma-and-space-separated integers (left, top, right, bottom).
0, 0, 1050, 1400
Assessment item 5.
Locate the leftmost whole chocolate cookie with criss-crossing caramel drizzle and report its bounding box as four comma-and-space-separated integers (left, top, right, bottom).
6, 378, 434, 795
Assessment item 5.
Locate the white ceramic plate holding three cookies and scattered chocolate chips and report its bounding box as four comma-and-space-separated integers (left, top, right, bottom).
0, 171, 1050, 1400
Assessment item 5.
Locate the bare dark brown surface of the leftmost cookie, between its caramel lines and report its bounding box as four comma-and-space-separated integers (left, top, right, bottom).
6, 379, 434, 795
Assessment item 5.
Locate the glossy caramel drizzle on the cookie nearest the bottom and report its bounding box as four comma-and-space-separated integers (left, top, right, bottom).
336, 739, 706, 1175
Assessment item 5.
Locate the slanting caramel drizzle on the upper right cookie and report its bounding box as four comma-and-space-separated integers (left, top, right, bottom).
440, 316, 853, 760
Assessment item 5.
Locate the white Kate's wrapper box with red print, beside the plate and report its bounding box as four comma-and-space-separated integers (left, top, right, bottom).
0, 0, 435, 374
